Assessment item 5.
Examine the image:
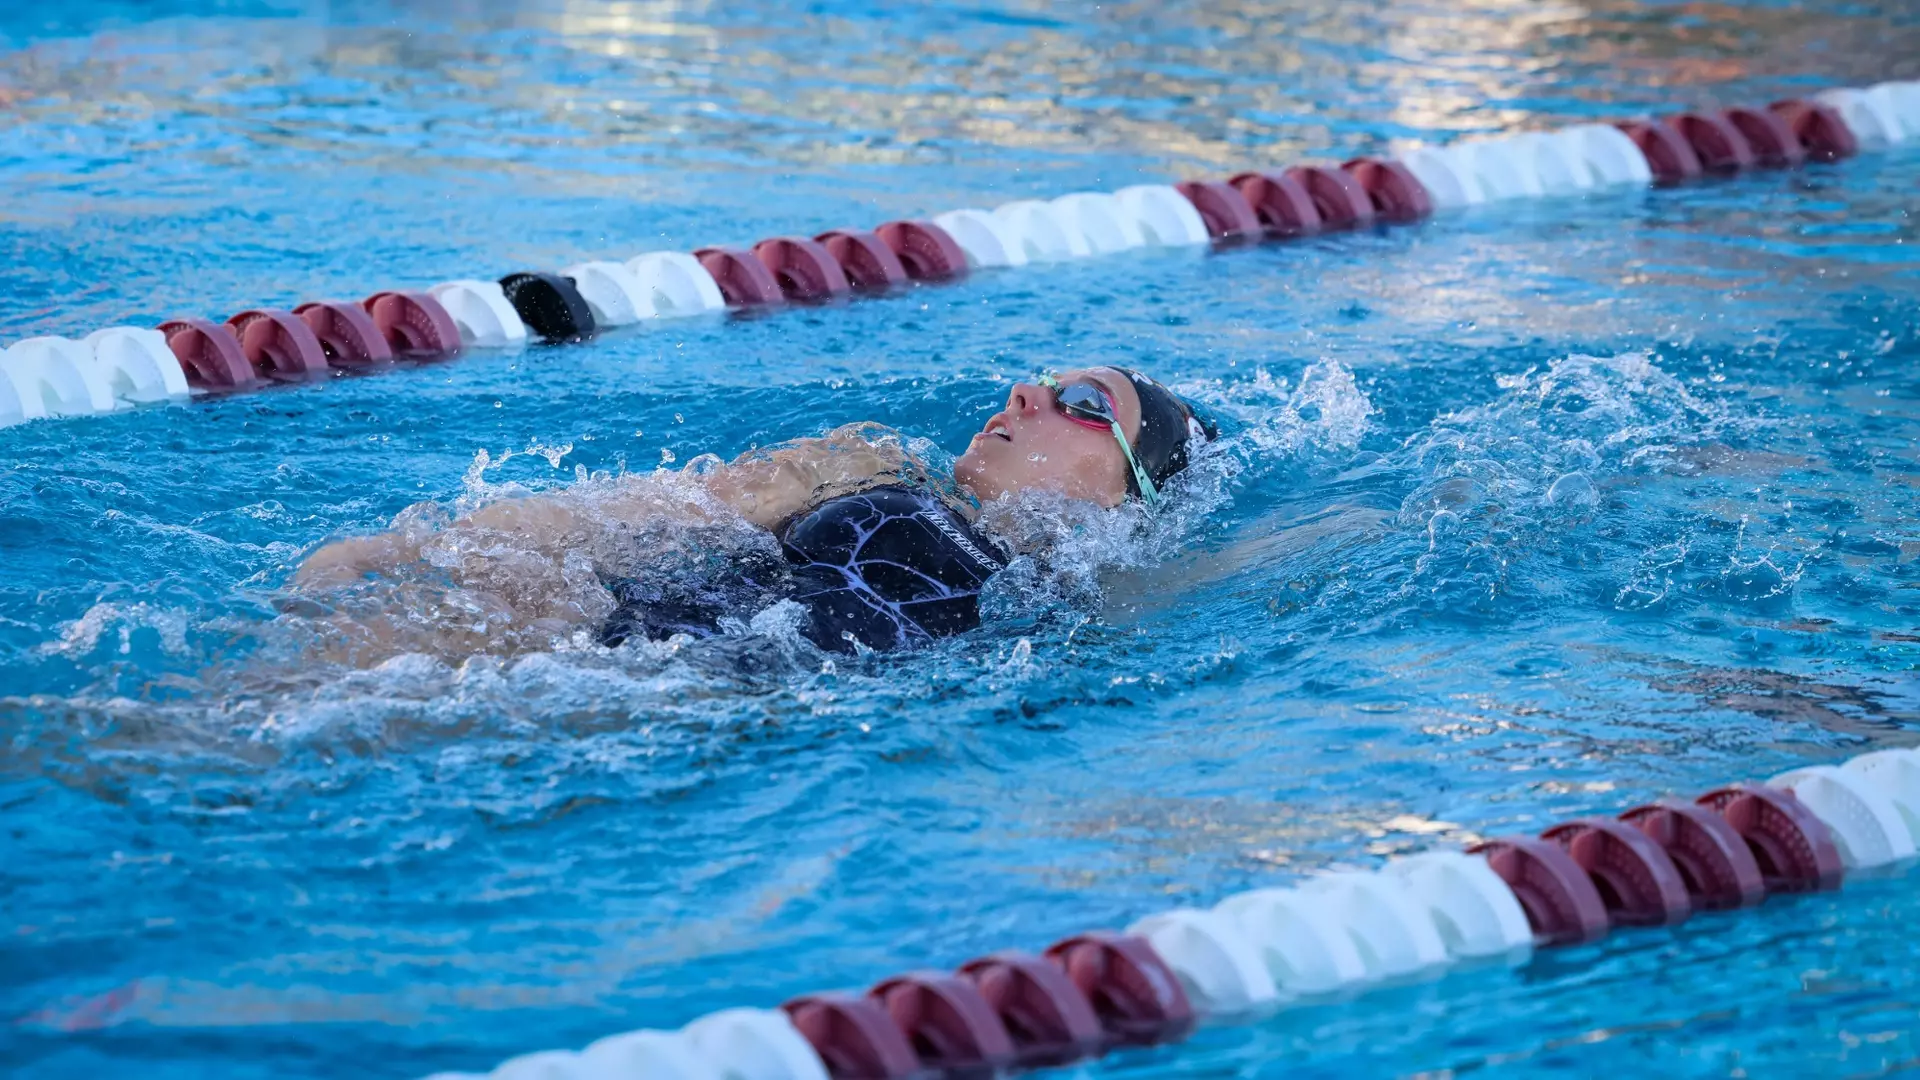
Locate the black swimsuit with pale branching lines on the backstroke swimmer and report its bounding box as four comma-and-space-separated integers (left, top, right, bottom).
601, 484, 1006, 651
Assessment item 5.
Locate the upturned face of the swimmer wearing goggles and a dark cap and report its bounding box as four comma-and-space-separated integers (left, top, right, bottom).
954, 367, 1140, 507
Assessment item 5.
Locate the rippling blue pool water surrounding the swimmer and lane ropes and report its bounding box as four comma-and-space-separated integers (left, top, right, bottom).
0, 0, 1920, 1078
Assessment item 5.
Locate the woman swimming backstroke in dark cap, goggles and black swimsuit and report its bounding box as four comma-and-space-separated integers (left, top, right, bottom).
294, 367, 1213, 651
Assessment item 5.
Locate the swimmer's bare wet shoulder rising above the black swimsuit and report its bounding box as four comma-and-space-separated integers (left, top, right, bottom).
703, 425, 906, 528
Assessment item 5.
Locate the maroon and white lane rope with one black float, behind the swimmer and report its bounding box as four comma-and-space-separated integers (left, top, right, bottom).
0, 83, 1920, 427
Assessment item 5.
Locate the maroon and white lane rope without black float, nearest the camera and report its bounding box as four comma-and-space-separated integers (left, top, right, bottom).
430, 749, 1920, 1080
